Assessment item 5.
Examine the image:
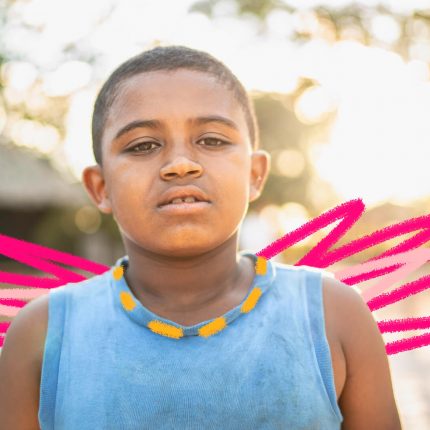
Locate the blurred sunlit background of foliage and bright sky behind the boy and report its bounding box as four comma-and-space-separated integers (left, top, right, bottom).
0, 0, 430, 429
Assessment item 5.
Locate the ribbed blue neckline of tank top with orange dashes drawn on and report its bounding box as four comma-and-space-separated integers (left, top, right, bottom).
108, 250, 276, 339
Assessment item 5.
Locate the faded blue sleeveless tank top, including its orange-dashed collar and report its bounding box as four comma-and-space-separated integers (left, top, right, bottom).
38, 251, 343, 430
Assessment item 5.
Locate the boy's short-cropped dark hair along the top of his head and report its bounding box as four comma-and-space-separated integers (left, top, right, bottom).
92, 45, 258, 166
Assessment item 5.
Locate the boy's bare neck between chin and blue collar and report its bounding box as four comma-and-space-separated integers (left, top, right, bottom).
121, 238, 255, 325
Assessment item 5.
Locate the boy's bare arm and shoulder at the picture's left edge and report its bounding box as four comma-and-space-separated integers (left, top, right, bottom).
0, 294, 48, 430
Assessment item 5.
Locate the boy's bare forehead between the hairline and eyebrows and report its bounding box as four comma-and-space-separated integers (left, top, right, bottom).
105, 69, 247, 141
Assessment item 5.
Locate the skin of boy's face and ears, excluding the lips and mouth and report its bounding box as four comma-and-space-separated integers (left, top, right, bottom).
83, 69, 270, 257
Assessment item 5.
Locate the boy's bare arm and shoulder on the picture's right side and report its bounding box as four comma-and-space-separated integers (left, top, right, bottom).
324, 278, 401, 430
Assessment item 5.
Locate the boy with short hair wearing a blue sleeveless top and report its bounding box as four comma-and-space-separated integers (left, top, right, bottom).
0, 46, 401, 430
